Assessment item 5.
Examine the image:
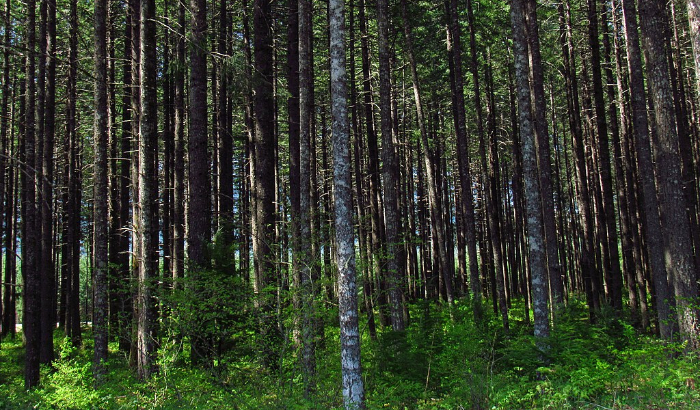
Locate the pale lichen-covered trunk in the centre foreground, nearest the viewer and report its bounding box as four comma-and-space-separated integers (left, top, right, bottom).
328, 0, 365, 404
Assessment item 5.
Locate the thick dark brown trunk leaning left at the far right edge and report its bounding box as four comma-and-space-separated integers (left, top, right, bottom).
639, 0, 699, 348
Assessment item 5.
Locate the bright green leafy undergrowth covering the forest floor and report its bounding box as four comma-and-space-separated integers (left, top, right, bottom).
0, 303, 700, 410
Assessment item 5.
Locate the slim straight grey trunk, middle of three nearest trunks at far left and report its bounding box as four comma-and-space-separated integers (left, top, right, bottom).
92, 0, 109, 374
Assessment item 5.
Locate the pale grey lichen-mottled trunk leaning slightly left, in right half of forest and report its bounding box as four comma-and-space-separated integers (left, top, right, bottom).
510, 0, 549, 342
